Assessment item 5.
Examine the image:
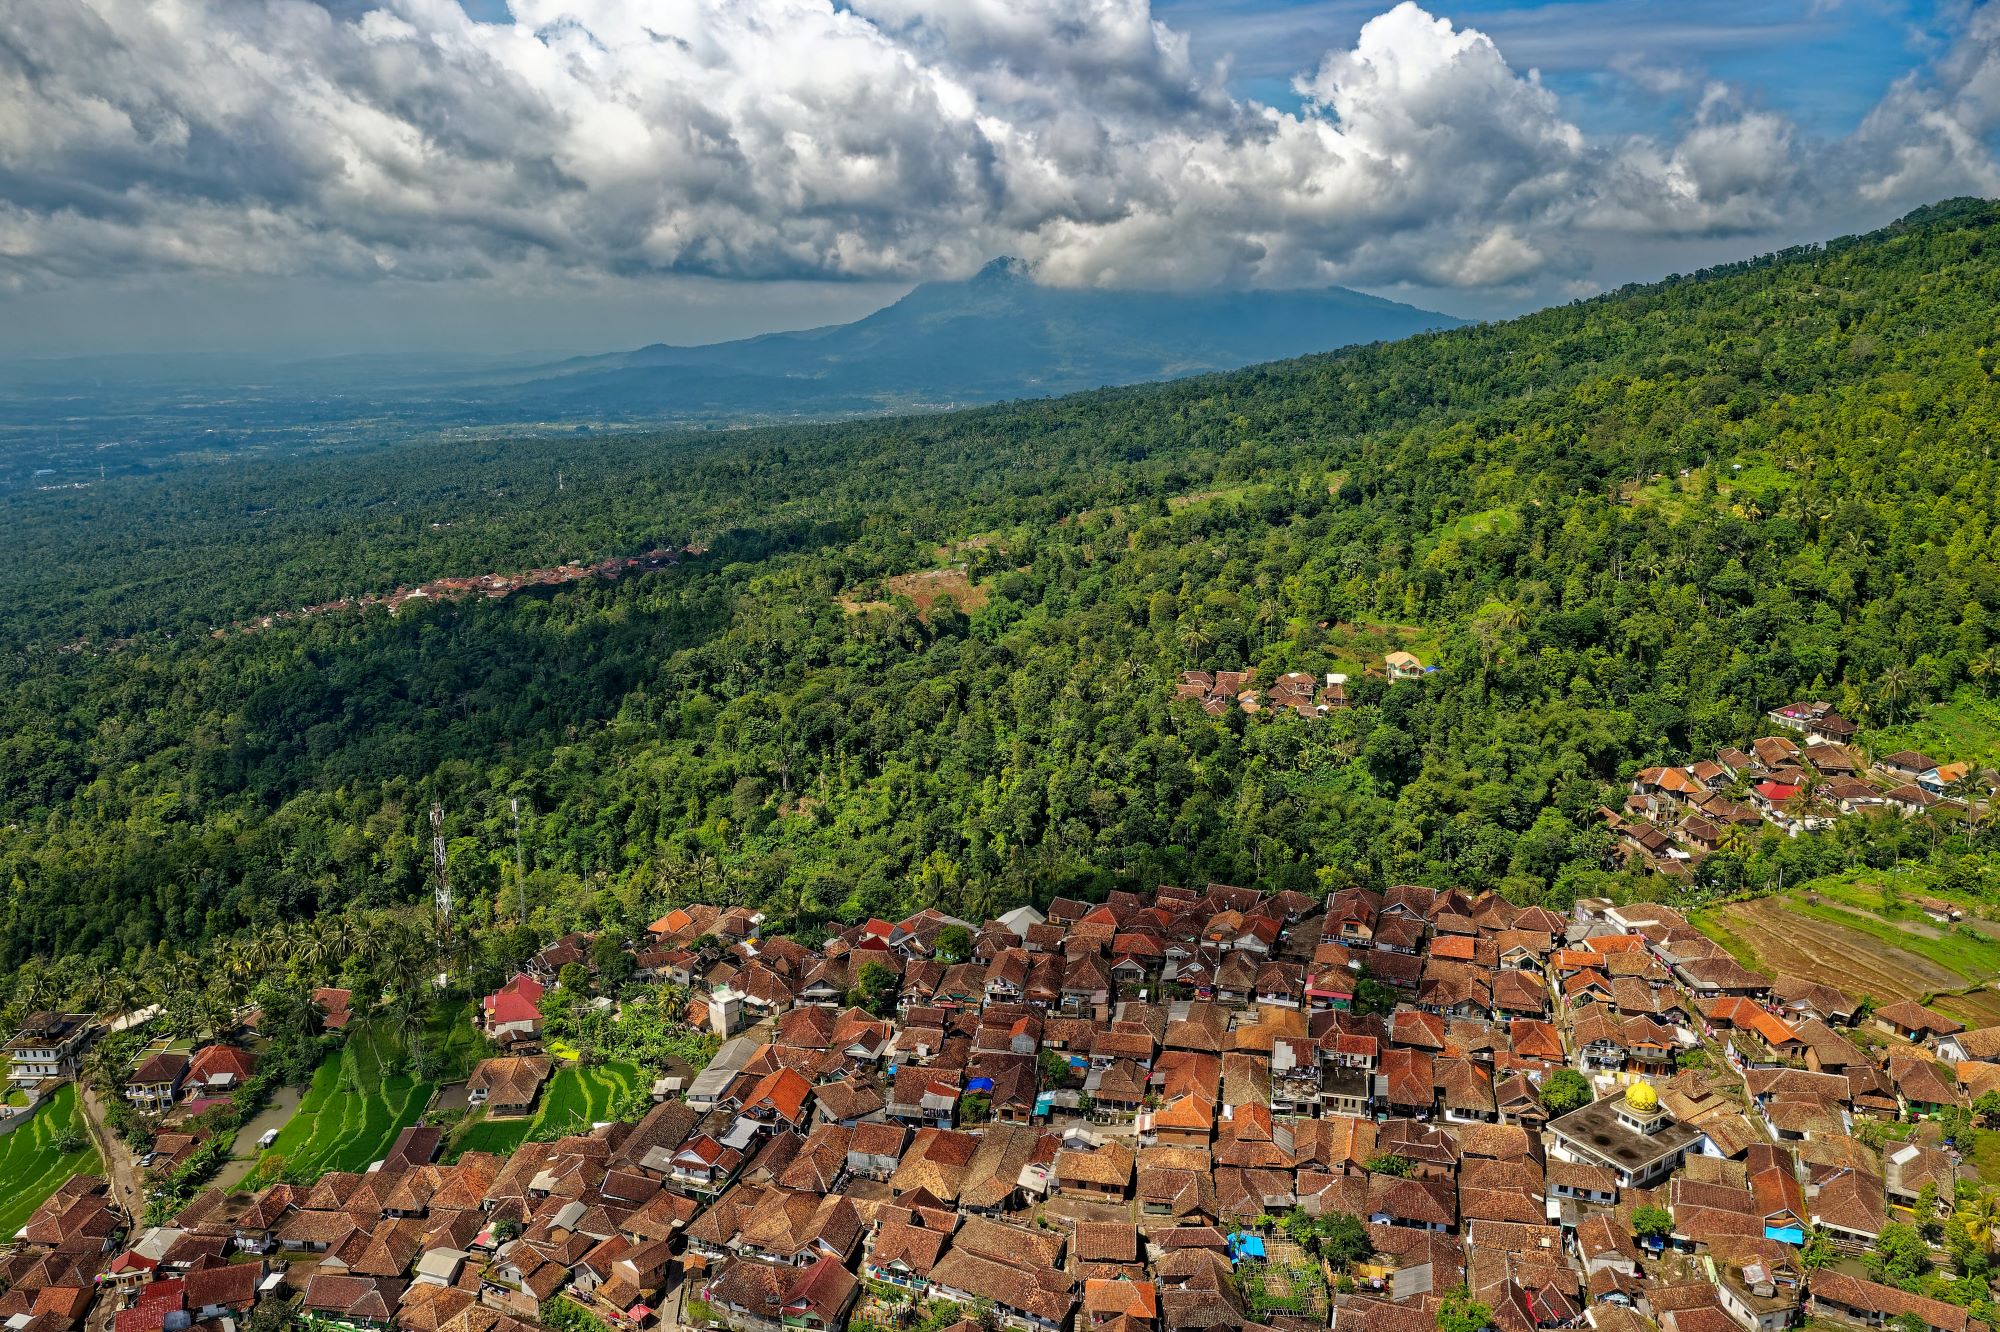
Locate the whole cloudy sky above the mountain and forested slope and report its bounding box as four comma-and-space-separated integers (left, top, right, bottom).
0, 0, 2000, 356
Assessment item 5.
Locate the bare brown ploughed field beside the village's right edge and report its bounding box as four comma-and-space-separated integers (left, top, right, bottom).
1704, 898, 1972, 1002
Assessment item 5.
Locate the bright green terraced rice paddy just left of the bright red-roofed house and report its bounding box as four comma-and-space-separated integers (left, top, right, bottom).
250, 1004, 484, 1186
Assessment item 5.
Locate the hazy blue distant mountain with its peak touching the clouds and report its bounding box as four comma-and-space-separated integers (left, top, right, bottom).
492, 260, 1462, 416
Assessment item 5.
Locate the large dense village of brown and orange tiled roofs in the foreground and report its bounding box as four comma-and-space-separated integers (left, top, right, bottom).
15, 884, 2000, 1332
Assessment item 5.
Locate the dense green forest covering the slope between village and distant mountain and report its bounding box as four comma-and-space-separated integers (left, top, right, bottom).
0, 200, 2000, 972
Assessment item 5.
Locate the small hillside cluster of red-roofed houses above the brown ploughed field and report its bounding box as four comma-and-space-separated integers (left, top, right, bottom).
1600, 702, 1972, 874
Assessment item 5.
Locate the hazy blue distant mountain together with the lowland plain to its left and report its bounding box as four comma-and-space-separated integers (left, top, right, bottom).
0, 260, 1462, 478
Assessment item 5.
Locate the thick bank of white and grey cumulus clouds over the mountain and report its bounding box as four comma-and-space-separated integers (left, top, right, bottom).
0, 0, 2000, 298
